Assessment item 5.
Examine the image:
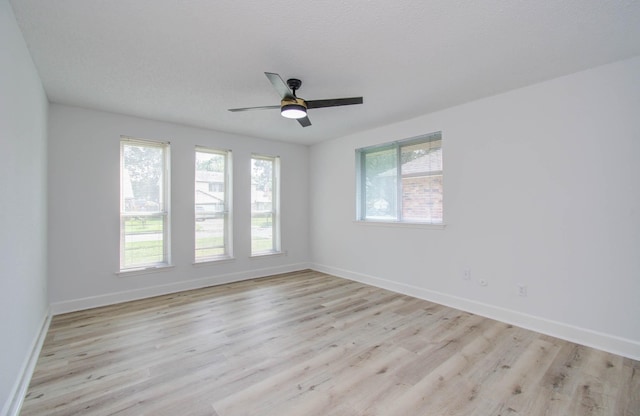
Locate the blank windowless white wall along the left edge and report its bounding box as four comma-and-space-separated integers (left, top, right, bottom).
0, 0, 48, 415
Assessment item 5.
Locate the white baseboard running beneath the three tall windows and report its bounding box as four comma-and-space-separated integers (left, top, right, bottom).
51, 263, 309, 315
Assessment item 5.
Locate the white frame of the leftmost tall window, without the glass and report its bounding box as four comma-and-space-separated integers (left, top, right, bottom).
119, 136, 171, 273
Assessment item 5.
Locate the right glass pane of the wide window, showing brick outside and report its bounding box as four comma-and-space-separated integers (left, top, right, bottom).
400, 140, 442, 223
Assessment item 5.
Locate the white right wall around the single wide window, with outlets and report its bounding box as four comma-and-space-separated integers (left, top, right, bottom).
310, 57, 640, 358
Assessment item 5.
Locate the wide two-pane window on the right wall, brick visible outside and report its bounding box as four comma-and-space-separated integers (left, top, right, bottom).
356, 132, 443, 224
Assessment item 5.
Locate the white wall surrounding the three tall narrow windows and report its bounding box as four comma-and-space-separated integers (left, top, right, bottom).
49, 104, 309, 313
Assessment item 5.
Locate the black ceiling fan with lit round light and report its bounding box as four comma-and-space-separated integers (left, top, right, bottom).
229, 72, 362, 127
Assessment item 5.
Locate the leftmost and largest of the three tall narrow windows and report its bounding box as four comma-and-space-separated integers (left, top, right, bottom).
120, 137, 171, 271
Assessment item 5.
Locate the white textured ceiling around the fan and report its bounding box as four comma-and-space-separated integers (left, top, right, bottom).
10, 0, 640, 144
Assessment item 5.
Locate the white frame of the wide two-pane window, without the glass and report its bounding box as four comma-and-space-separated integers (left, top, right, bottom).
355, 132, 445, 229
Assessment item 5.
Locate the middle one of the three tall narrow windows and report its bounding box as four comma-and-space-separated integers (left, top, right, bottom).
194, 147, 232, 263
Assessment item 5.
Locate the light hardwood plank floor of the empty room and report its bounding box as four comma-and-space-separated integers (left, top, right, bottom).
21, 271, 640, 416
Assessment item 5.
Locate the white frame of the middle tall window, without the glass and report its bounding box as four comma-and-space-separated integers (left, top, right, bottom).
194, 146, 233, 264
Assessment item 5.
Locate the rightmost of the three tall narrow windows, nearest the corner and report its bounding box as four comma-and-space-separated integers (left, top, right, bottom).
251, 155, 280, 256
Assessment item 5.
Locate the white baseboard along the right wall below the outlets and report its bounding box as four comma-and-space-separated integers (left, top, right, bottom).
310, 264, 640, 360
